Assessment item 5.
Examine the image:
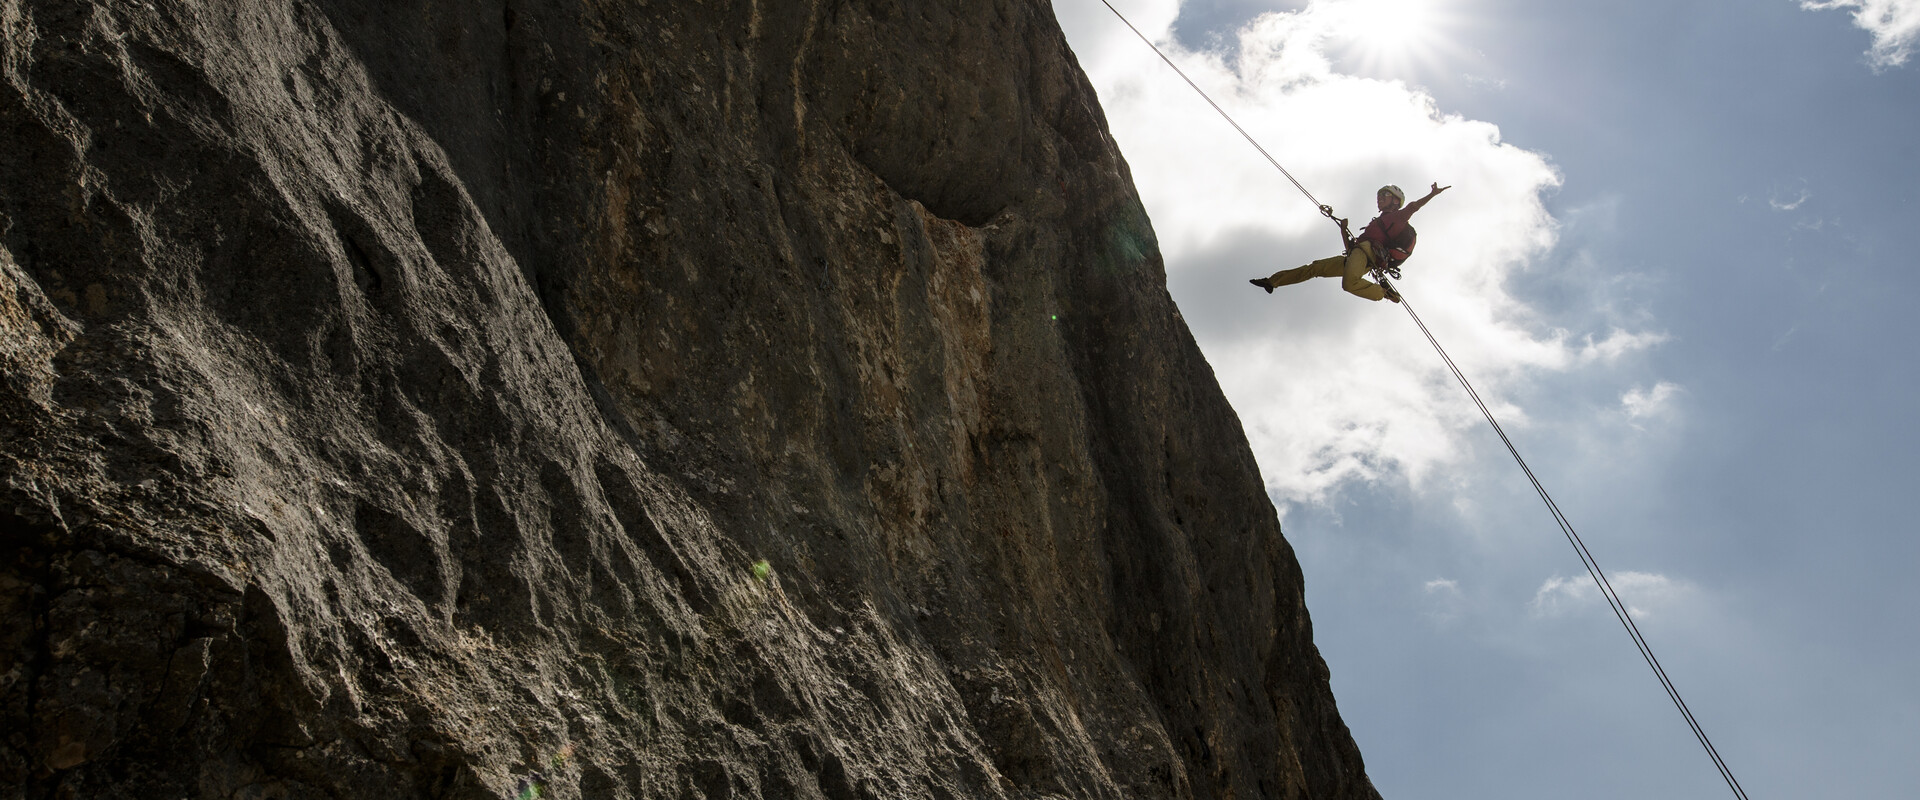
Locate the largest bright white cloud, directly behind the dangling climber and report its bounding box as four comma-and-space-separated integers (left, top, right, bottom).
1056, 0, 1665, 508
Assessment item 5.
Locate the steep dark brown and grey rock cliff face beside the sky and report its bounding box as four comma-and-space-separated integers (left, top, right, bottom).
0, 0, 1377, 800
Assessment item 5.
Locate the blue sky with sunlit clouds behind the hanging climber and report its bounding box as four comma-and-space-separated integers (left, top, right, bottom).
1054, 0, 1920, 800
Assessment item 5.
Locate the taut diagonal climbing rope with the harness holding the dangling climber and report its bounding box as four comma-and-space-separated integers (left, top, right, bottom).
1100, 0, 1747, 800
